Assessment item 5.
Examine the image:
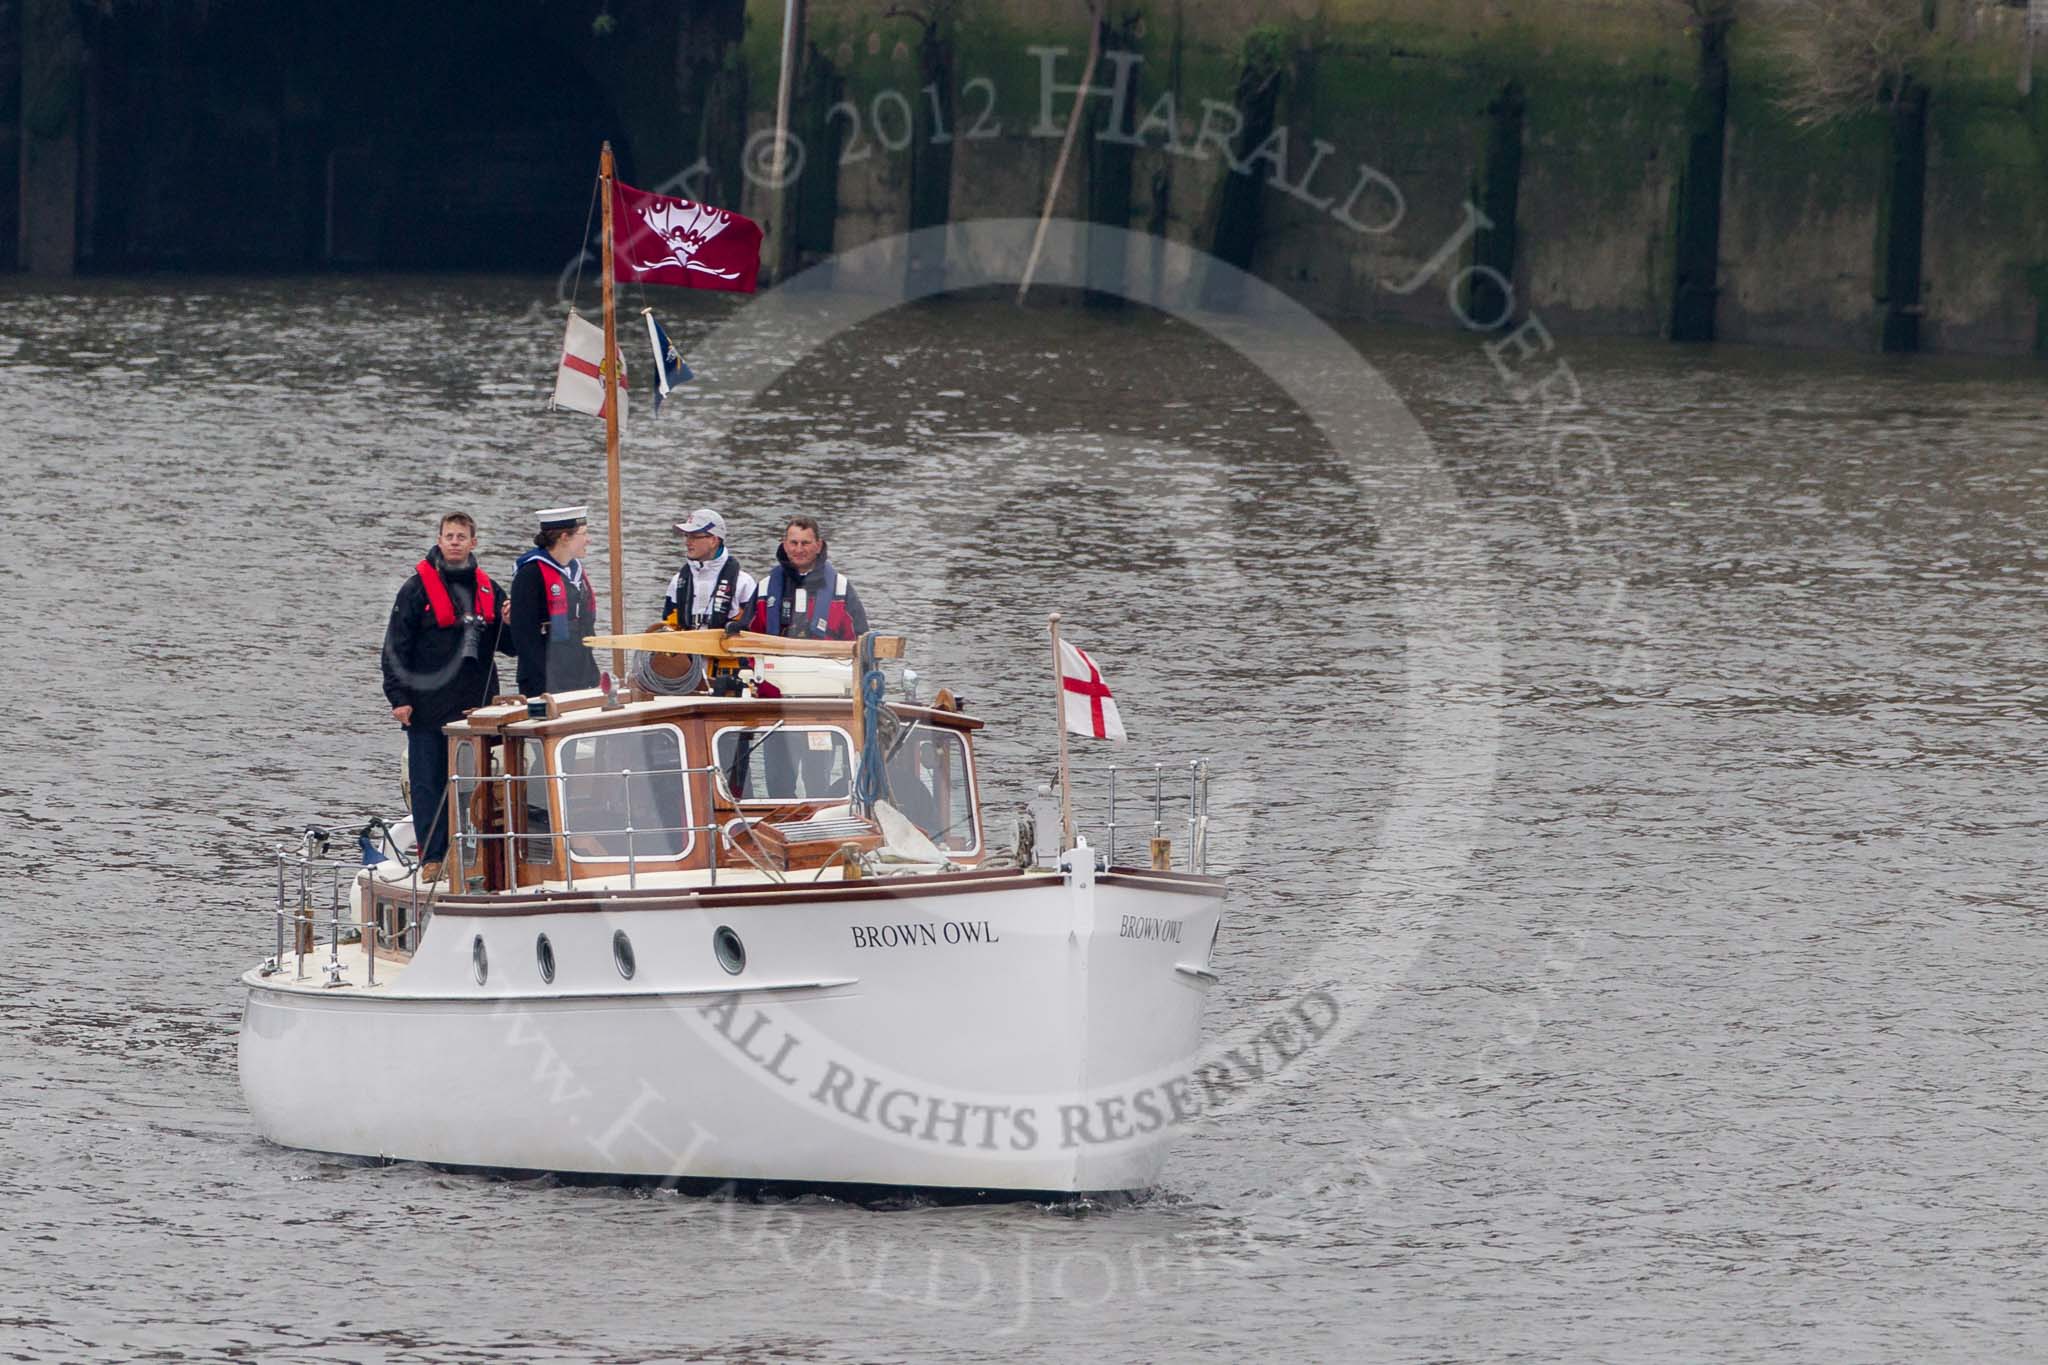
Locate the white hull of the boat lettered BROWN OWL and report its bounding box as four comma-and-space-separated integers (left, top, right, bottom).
240, 870, 1221, 1193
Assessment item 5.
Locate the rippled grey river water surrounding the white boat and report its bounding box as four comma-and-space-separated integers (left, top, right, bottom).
0, 276, 2048, 1361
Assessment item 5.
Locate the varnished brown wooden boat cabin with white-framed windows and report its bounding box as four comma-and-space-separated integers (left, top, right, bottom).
432, 690, 985, 894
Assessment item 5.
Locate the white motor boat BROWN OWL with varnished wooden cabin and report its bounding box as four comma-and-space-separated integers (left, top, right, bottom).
240, 636, 1223, 1195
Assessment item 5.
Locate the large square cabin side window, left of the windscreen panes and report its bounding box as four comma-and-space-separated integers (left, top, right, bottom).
555, 724, 694, 862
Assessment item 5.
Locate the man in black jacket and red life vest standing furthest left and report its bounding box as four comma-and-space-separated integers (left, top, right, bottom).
383, 512, 512, 880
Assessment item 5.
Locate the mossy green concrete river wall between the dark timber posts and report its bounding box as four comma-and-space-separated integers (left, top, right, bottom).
748, 0, 2048, 352
